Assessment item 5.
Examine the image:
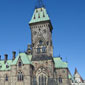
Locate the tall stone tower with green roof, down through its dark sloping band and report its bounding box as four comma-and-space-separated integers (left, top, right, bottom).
29, 7, 53, 60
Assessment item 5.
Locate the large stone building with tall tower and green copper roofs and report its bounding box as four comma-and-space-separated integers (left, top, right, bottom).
0, 3, 84, 85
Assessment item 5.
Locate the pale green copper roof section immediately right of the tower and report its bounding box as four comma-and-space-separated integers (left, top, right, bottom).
53, 57, 68, 68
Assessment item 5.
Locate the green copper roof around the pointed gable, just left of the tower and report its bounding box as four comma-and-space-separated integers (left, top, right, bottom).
12, 53, 31, 65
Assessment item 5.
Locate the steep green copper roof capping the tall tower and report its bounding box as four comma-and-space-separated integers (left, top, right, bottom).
29, 7, 50, 24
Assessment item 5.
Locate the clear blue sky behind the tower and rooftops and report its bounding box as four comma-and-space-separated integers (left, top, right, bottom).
0, 0, 85, 79
